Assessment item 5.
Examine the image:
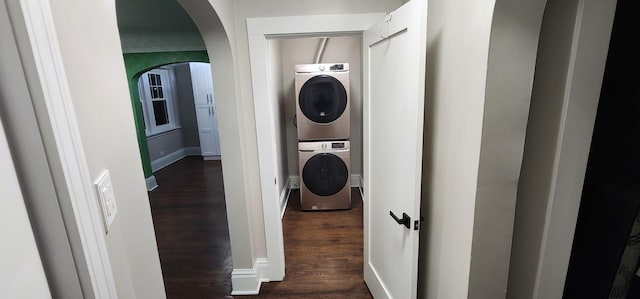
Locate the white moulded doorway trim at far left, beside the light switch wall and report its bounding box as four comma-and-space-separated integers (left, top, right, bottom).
6, 1, 118, 298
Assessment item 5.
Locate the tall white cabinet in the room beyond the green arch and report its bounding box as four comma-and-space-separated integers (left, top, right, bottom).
189, 62, 220, 160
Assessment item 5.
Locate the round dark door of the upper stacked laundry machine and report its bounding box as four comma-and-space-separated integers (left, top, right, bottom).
298, 75, 347, 124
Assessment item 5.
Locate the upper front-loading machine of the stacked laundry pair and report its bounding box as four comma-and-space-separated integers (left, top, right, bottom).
295, 63, 351, 141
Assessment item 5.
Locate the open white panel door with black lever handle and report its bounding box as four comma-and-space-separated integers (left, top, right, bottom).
363, 0, 427, 299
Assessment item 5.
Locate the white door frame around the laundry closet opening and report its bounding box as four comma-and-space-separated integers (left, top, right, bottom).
247, 13, 385, 281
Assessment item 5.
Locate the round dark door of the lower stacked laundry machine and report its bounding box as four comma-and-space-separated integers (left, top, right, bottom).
302, 154, 349, 196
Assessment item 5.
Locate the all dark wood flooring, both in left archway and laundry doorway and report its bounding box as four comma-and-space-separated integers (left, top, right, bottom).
149, 157, 372, 299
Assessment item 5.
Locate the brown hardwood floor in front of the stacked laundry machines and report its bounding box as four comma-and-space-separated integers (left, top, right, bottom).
251, 188, 372, 299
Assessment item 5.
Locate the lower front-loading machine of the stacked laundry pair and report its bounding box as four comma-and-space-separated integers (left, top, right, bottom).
298, 141, 351, 210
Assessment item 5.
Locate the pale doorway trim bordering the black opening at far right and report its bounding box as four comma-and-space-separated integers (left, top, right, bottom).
510, 0, 617, 298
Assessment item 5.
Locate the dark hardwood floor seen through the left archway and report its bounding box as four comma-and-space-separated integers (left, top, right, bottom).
149, 157, 233, 299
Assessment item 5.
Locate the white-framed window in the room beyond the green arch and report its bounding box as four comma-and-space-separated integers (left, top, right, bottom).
138, 69, 178, 136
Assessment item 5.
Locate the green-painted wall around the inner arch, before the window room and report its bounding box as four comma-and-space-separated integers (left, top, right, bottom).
123, 51, 209, 178
